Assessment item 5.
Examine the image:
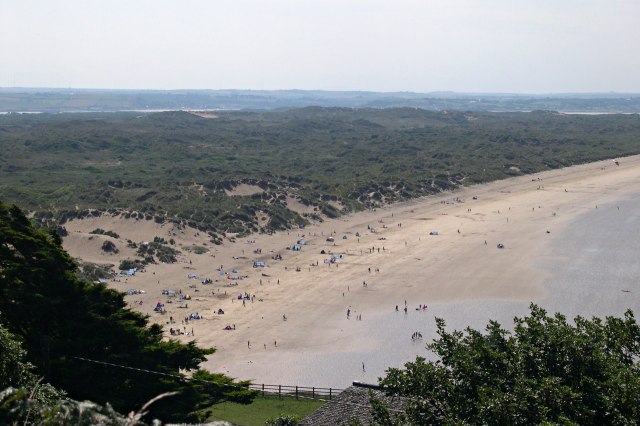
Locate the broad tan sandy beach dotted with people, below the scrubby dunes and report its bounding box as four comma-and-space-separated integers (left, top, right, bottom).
64, 156, 640, 387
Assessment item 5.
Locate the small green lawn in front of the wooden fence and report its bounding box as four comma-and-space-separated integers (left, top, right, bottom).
209, 396, 324, 426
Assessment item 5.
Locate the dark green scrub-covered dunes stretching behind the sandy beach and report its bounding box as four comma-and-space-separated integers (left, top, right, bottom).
0, 108, 640, 238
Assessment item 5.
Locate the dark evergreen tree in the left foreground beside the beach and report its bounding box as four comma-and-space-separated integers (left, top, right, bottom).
0, 203, 252, 420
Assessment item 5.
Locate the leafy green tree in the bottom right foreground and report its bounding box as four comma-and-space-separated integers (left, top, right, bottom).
380, 304, 640, 424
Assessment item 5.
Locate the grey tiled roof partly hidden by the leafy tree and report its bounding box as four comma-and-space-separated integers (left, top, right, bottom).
299, 383, 408, 426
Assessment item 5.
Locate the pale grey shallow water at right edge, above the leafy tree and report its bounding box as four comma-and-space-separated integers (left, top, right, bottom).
540, 194, 640, 318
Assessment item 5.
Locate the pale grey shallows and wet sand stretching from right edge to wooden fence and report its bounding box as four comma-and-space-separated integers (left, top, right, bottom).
248, 198, 640, 388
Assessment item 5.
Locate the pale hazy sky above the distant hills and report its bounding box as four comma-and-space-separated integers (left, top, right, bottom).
0, 0, 640, 93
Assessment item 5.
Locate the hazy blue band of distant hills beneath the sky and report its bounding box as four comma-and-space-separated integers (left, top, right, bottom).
0, 88, 640, 113
